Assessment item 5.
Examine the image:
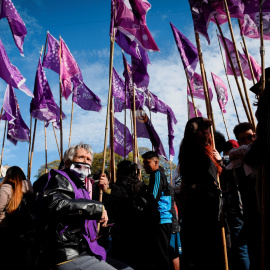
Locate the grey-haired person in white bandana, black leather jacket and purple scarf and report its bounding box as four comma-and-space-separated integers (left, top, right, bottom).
37, 143, 132, 270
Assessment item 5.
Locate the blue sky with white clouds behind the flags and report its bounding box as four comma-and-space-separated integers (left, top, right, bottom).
0, 0, 269, 182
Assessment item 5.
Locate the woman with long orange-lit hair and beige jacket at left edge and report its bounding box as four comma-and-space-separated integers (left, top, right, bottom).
0, 166, 34, 269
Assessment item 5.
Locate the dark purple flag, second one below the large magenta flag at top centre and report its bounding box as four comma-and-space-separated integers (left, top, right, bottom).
131, 46, 150, 88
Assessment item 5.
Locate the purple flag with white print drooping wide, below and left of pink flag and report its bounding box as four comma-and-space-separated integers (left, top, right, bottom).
30, 56, 66, 129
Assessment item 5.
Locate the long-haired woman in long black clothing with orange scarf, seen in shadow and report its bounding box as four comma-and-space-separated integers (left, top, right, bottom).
179, 117, 223, 270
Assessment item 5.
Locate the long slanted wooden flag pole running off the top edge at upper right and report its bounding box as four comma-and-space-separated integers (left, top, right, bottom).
223, 0, 256, 130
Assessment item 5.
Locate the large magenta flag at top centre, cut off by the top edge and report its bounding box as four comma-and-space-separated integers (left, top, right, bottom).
111, 0, 159, 52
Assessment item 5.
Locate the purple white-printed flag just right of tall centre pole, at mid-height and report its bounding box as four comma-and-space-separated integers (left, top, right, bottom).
112, 68, 131, 112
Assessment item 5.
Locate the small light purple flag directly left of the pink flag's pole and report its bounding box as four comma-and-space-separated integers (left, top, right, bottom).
42, 33, 60, 74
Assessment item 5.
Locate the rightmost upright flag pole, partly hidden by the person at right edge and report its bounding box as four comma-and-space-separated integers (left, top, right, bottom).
259, 0, 269, 270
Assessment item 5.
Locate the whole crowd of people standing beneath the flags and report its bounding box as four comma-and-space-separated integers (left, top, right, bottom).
0, 74, 270, 270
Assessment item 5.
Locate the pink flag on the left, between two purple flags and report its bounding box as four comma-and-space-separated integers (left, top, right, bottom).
60, 38, 81, 99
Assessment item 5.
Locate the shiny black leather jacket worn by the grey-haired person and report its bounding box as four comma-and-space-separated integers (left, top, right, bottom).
37, 169, 103, 265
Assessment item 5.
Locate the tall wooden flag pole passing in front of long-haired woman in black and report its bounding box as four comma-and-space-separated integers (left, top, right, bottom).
195, 33, 229, 270
